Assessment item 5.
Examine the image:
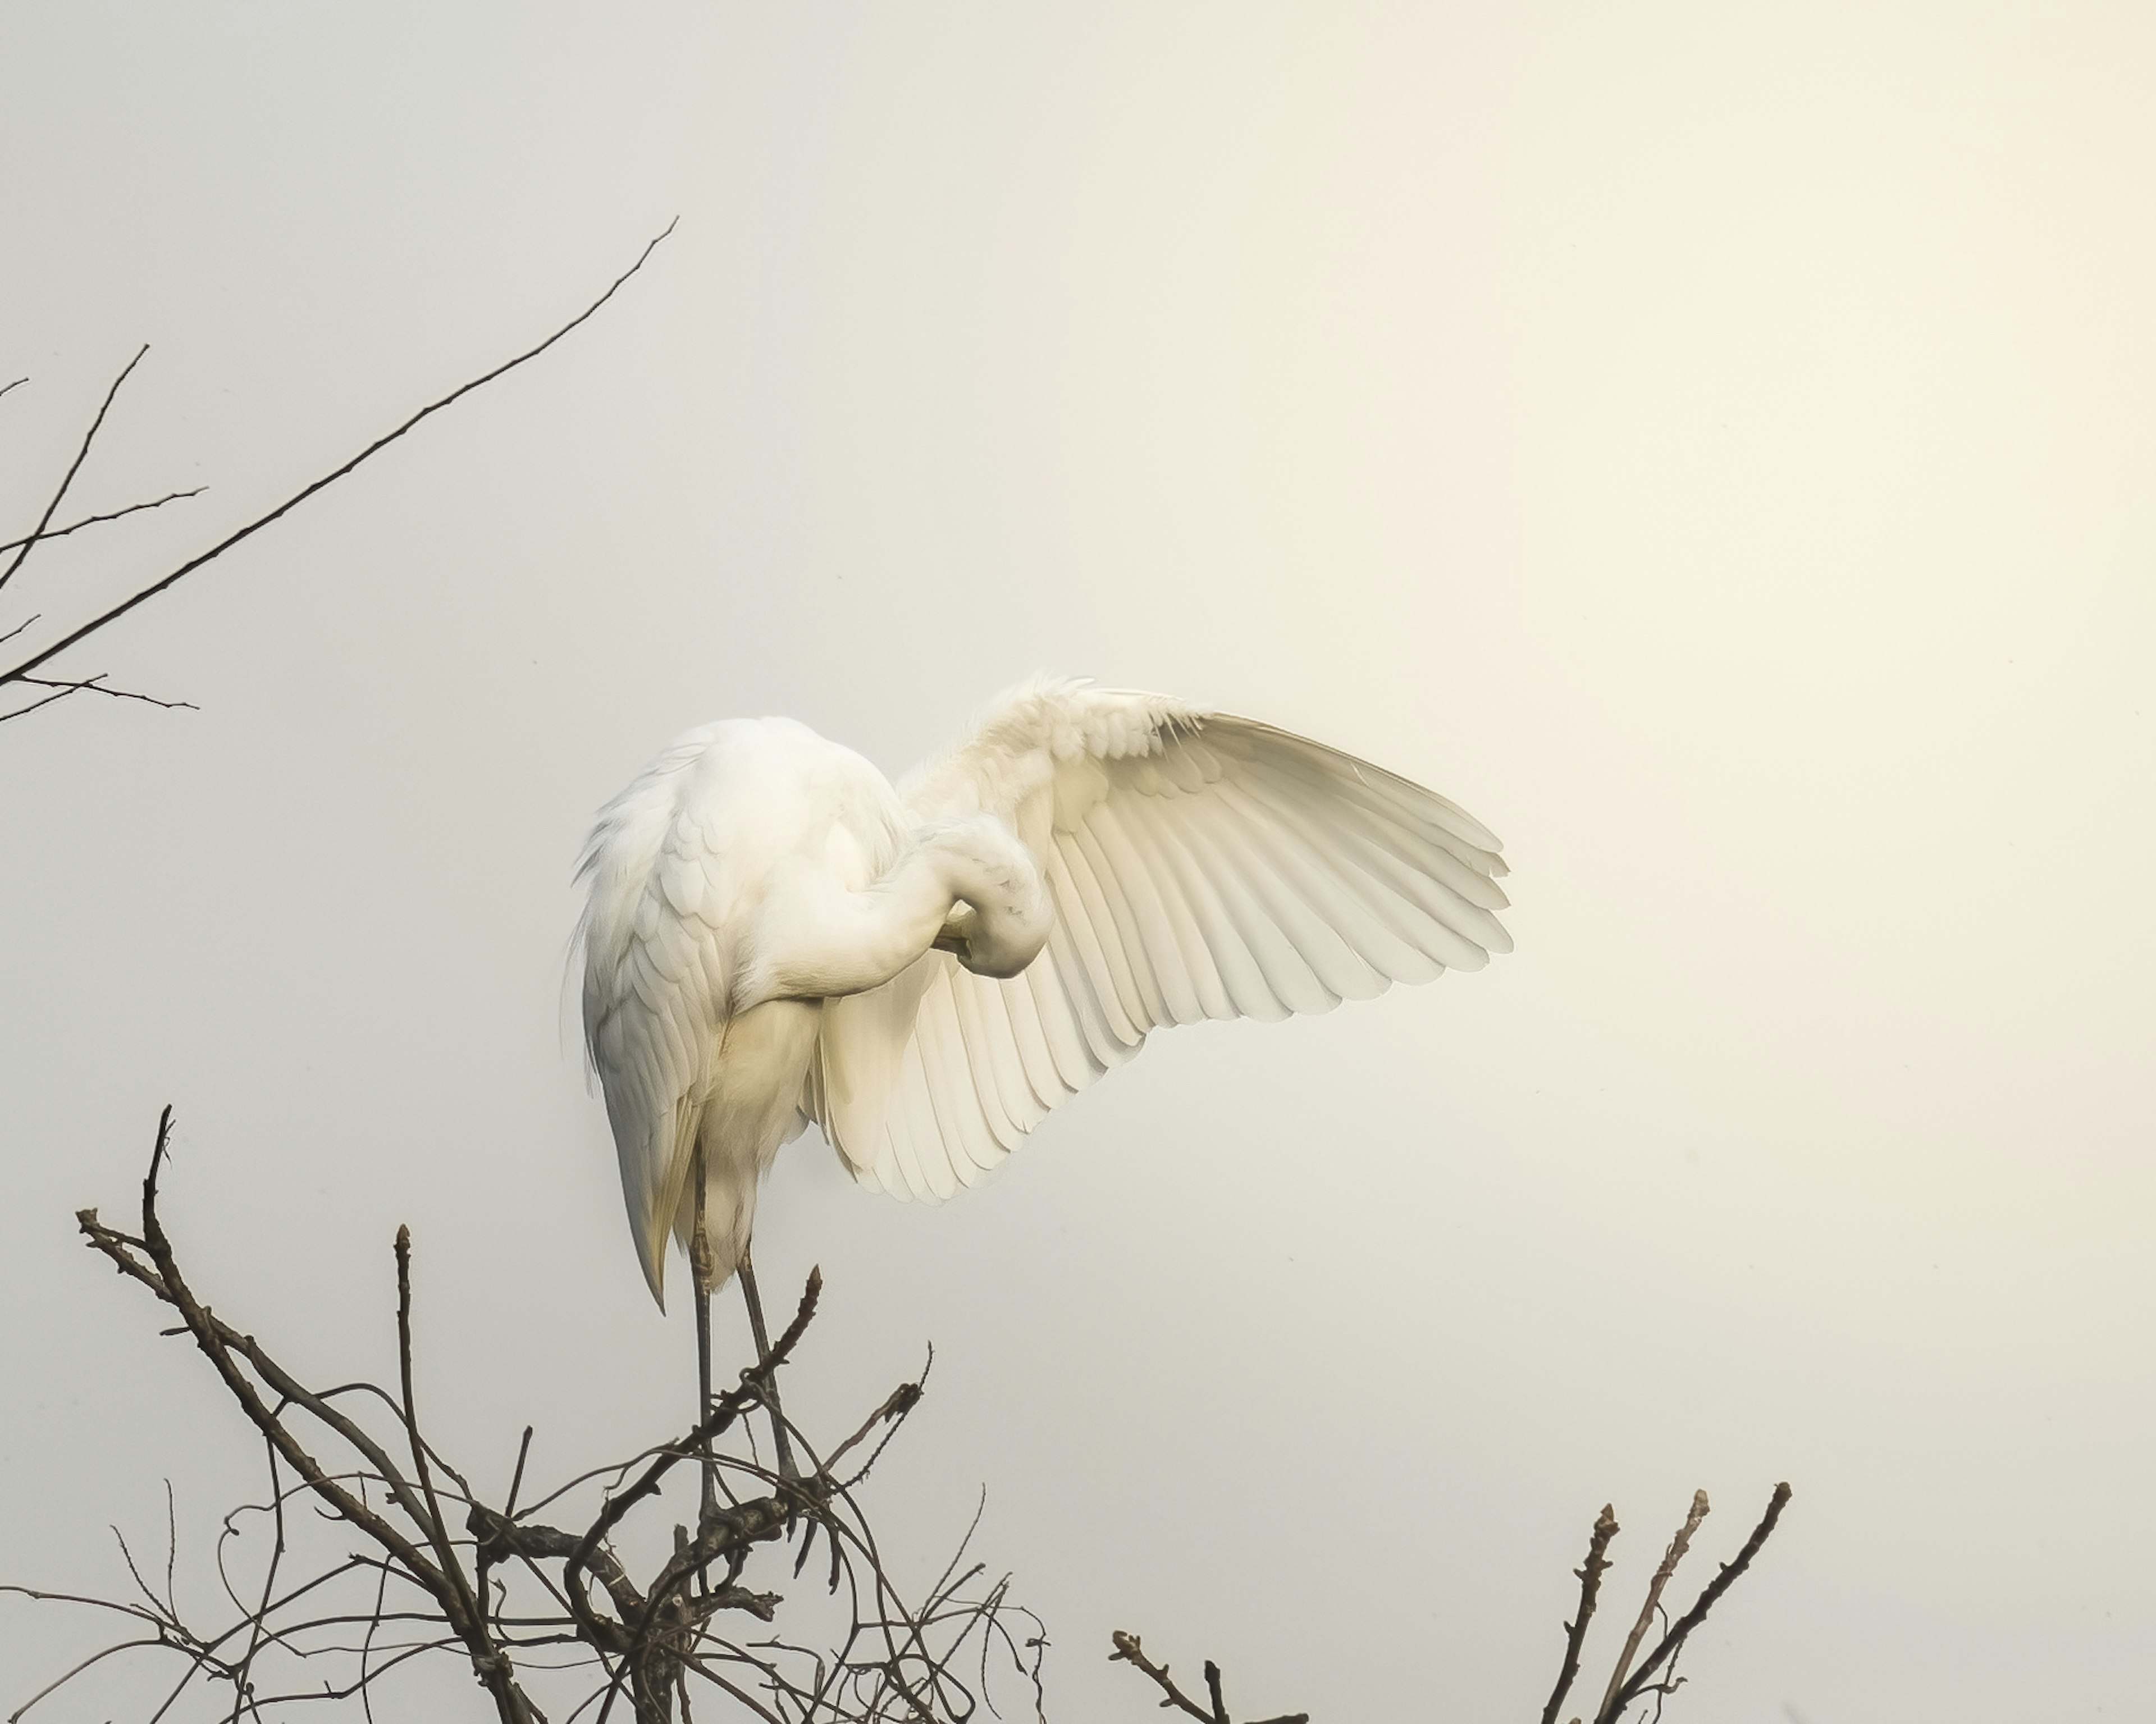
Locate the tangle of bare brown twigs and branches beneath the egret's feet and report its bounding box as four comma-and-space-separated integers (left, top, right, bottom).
0, 1108, 1045, 1724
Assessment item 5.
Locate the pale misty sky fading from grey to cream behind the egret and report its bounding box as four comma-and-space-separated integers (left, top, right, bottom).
0, 0, 2156, 1724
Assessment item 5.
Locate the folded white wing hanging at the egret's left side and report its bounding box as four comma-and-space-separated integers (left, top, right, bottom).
575, 730, 729, 1297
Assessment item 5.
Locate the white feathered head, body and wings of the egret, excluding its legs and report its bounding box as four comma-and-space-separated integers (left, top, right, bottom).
578, 681, 1511, 1297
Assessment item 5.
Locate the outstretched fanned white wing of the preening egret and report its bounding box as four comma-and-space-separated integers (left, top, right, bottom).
804, 683, 1511, 1200
